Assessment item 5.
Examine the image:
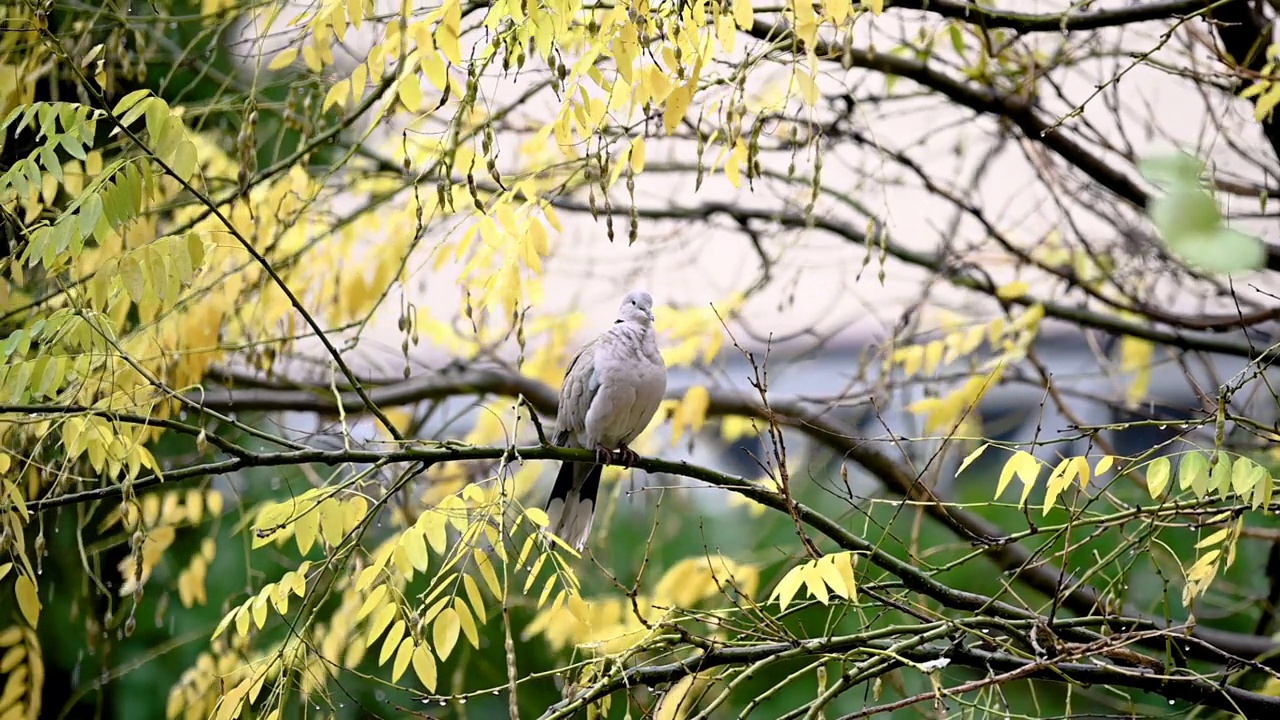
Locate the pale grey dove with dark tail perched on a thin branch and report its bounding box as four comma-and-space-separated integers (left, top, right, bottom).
547, 291, 667, 551
